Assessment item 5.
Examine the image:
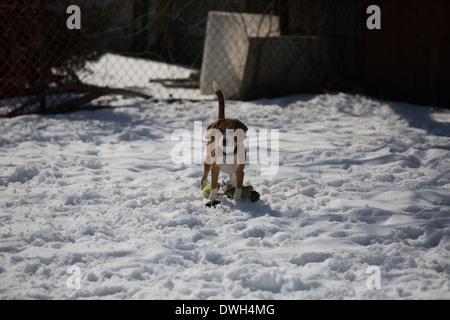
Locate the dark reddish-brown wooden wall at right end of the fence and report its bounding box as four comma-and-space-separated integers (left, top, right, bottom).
357, 0, 450, 108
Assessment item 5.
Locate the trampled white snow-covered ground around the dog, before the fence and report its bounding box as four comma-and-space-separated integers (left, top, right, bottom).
0, 55, 450, 299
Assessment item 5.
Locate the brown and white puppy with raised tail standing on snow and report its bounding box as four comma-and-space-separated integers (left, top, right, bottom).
201, 82, 248, 201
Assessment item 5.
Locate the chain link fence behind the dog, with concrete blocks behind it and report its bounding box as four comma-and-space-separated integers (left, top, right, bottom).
0, 0, 358, 116
